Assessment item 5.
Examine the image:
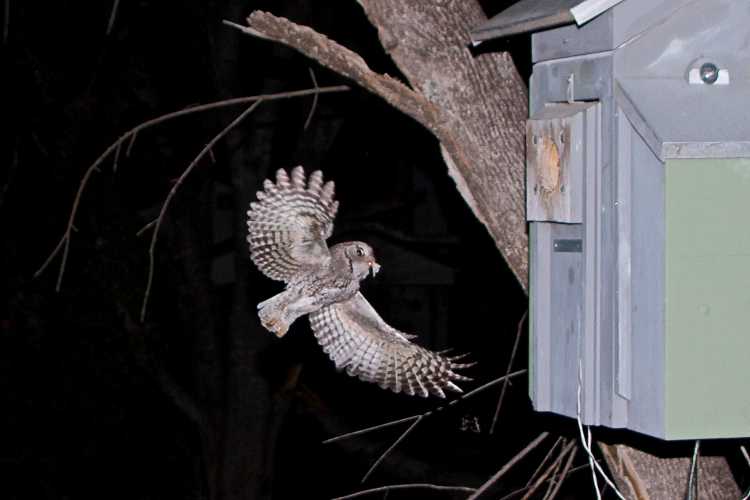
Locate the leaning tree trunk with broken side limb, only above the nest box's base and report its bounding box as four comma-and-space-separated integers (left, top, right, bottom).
244, 6, 528, 289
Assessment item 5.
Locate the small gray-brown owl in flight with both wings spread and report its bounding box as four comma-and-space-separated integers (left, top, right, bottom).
247, 166, 471, 397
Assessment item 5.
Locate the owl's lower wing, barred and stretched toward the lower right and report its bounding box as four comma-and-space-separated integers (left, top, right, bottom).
310, 293, 472, 398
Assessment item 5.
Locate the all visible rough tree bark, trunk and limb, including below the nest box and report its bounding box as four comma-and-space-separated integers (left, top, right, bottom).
238, 0, 739, 500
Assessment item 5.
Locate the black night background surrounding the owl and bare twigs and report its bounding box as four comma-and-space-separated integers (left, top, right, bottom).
0, 0, 628, 500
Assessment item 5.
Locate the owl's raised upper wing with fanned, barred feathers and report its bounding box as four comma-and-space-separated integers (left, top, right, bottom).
247, 166, 339, 282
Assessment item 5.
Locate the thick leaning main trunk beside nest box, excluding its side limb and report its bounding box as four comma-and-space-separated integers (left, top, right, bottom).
359, 0, 528, 289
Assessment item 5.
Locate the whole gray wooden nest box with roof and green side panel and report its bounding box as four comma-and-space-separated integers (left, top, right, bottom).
472, 0, 750, 439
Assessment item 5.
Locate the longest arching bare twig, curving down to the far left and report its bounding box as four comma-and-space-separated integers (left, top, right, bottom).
33, 85, 349, 292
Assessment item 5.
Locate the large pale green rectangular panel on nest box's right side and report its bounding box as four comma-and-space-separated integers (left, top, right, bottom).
665, 159, 750, 439
